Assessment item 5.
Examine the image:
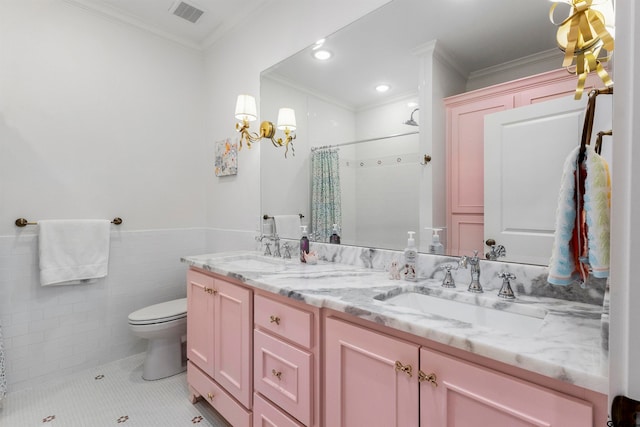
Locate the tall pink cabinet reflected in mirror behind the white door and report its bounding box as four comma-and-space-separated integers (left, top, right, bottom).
445, 69, 602, 255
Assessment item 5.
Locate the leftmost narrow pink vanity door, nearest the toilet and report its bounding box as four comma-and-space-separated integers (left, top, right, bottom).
187, 270, 213, 376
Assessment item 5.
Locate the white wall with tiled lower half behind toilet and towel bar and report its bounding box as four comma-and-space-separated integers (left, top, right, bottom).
0, 0, 206, 391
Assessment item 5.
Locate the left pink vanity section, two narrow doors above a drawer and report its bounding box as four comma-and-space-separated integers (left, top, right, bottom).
187, 268, 253, 427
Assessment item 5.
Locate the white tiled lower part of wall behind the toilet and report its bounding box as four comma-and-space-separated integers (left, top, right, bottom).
0, 227, 228, 392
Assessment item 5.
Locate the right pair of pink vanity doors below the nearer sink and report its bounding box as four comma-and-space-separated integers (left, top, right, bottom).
324, 312, 607, 427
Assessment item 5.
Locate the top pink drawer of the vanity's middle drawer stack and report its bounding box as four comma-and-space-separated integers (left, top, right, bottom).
253, 295, 313, 348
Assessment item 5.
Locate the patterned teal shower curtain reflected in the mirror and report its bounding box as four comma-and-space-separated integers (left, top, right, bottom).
311, 148, 342, 242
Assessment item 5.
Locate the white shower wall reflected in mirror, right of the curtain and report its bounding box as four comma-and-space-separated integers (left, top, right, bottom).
352, 98, 423, 250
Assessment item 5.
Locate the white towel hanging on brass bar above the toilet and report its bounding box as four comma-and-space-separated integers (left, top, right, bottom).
38, 220, 111, 286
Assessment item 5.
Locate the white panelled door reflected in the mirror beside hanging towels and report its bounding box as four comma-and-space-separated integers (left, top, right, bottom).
484, 96, 612, 264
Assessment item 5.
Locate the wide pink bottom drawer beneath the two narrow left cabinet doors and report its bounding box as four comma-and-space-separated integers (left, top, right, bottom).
187, 361, 252, 427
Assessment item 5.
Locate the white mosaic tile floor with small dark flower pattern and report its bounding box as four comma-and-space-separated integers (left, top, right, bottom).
0, 354, 230, 427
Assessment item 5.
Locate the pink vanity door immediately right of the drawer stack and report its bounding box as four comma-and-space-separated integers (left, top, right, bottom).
324, 318, 419, 427
